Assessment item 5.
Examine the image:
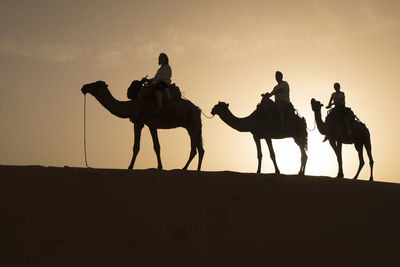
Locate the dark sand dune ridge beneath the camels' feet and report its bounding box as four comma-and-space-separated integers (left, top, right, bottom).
0, 166, 400, 267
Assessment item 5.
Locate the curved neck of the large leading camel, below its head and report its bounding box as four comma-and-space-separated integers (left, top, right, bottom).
91, 88, 136, 118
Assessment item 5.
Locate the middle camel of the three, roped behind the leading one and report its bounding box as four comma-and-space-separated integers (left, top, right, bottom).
211, 99, 307, 175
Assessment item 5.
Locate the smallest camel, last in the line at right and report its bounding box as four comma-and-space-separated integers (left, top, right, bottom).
311, 98, 374, 181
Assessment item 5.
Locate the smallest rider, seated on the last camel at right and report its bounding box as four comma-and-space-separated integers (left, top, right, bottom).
324, 83, 354, 137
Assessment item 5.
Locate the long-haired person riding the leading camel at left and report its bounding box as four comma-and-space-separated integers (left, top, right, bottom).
142, 53, 172, 114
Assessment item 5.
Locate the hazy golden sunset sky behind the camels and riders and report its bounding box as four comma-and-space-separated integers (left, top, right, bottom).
0, 0, 400, 183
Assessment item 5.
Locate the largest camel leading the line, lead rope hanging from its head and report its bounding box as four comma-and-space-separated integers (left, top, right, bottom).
81, 81, 204, 171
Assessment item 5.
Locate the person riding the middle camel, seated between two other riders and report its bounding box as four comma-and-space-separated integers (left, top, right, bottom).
266, 71, 290, 126
